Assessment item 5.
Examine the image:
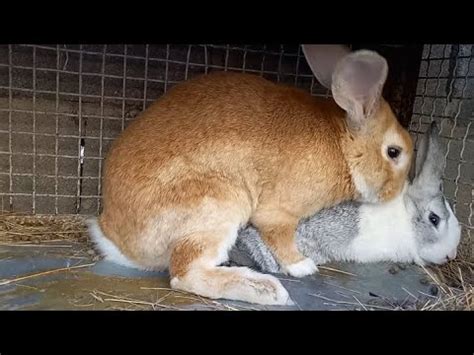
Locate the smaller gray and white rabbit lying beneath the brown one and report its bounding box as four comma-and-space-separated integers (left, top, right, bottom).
229, 122, 461, 273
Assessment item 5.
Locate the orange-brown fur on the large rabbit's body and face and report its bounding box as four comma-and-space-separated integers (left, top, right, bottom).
99, 73, 412, 304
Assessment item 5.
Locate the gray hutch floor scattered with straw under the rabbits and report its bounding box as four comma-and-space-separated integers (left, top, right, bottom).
0, 216, 438, 310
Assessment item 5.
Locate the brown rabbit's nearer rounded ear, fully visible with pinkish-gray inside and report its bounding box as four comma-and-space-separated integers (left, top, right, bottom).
332, 50, 388, 127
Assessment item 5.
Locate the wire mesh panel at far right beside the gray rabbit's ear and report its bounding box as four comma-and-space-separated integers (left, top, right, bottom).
410, 45, 474, 250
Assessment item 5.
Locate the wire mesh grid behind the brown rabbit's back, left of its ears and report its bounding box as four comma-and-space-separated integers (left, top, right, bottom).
0, 45, 328, 214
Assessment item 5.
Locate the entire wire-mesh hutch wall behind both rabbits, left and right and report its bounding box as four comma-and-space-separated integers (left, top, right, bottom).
0, 44, 474, 308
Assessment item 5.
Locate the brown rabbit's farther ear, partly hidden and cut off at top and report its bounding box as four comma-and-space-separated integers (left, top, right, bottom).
301, 44, 350, 89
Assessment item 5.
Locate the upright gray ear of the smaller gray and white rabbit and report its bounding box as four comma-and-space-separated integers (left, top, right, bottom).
413, 121, 446, 194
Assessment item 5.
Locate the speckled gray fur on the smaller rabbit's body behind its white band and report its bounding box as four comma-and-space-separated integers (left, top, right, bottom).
229, 202, 360, 273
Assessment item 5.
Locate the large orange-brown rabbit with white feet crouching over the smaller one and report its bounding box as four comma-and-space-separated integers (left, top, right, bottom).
90, 45, 413, 304
